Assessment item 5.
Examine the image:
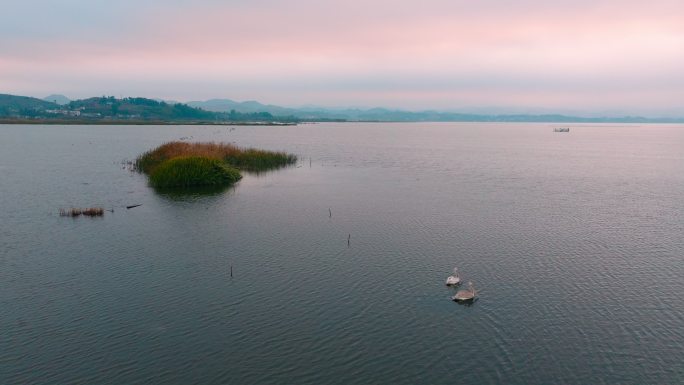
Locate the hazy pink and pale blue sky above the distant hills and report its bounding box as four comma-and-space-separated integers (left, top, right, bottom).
0, 0, 684, 116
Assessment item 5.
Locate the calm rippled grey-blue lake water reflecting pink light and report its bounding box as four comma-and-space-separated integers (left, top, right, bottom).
0, 123, 684, 385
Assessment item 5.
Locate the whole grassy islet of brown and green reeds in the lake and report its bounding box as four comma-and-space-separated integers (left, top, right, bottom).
135, 142, 297, 188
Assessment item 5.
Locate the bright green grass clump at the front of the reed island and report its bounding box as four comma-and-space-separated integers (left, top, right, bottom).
149, 156, 242, 188
